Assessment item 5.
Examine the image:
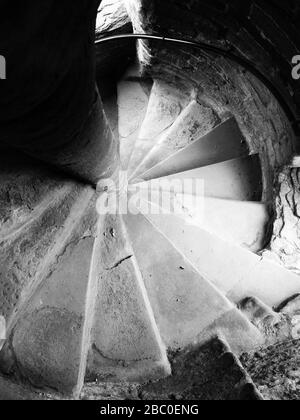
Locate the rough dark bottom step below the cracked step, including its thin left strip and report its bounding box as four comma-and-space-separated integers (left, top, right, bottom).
81, 337, 262, 400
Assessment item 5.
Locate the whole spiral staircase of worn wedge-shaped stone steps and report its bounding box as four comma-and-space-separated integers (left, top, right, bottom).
0, 62, 300, 397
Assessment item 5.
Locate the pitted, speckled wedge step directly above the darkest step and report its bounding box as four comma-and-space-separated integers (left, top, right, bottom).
132, 100, 220, 181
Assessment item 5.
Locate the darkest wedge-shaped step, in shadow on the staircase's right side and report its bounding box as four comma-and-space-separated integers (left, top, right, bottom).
139, 118, 249, 181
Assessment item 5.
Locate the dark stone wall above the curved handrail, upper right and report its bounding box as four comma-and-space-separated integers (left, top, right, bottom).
125, 0, 300, 131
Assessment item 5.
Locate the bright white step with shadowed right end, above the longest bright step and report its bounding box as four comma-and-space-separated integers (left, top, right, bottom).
143, 194, 270, 252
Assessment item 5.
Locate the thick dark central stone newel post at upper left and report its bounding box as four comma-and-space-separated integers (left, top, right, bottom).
0, 0, 118, 185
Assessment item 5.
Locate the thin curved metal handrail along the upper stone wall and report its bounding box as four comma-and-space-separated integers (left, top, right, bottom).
95, 34, 300, 129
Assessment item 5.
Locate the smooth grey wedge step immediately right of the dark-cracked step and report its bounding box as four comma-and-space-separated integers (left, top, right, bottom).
124, 210, 262, 351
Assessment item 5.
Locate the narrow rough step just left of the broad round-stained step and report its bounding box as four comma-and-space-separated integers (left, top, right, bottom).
0, 182, 94, 330
